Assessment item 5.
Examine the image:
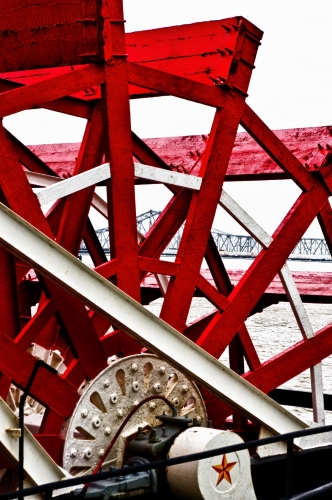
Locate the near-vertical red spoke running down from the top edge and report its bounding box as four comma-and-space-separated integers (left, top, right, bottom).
102, 0, 140, 301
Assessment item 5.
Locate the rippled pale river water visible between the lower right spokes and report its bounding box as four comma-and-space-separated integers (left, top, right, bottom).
146, 298, 332, 424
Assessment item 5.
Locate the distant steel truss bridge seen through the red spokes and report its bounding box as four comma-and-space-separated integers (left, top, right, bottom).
80, 210, 332, 262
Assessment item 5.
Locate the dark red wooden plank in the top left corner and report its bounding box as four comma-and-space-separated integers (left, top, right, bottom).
0, 0, 98, 72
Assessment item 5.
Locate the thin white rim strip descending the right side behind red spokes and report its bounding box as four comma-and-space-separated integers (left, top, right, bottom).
219, 191, 325, 424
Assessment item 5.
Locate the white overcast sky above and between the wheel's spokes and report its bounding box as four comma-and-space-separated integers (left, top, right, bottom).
5, 0, 332, 256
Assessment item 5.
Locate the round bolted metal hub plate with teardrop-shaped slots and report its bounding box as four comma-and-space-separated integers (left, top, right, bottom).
63, 354, 207, 474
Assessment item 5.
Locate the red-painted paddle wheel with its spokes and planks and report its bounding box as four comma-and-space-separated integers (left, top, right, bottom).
0, 0, 332, 460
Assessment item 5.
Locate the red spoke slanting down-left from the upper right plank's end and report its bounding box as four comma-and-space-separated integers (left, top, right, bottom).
161, 98, 248, 331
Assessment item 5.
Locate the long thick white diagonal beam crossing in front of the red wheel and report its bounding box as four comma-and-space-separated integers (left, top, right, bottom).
0, 204, 308, 440
